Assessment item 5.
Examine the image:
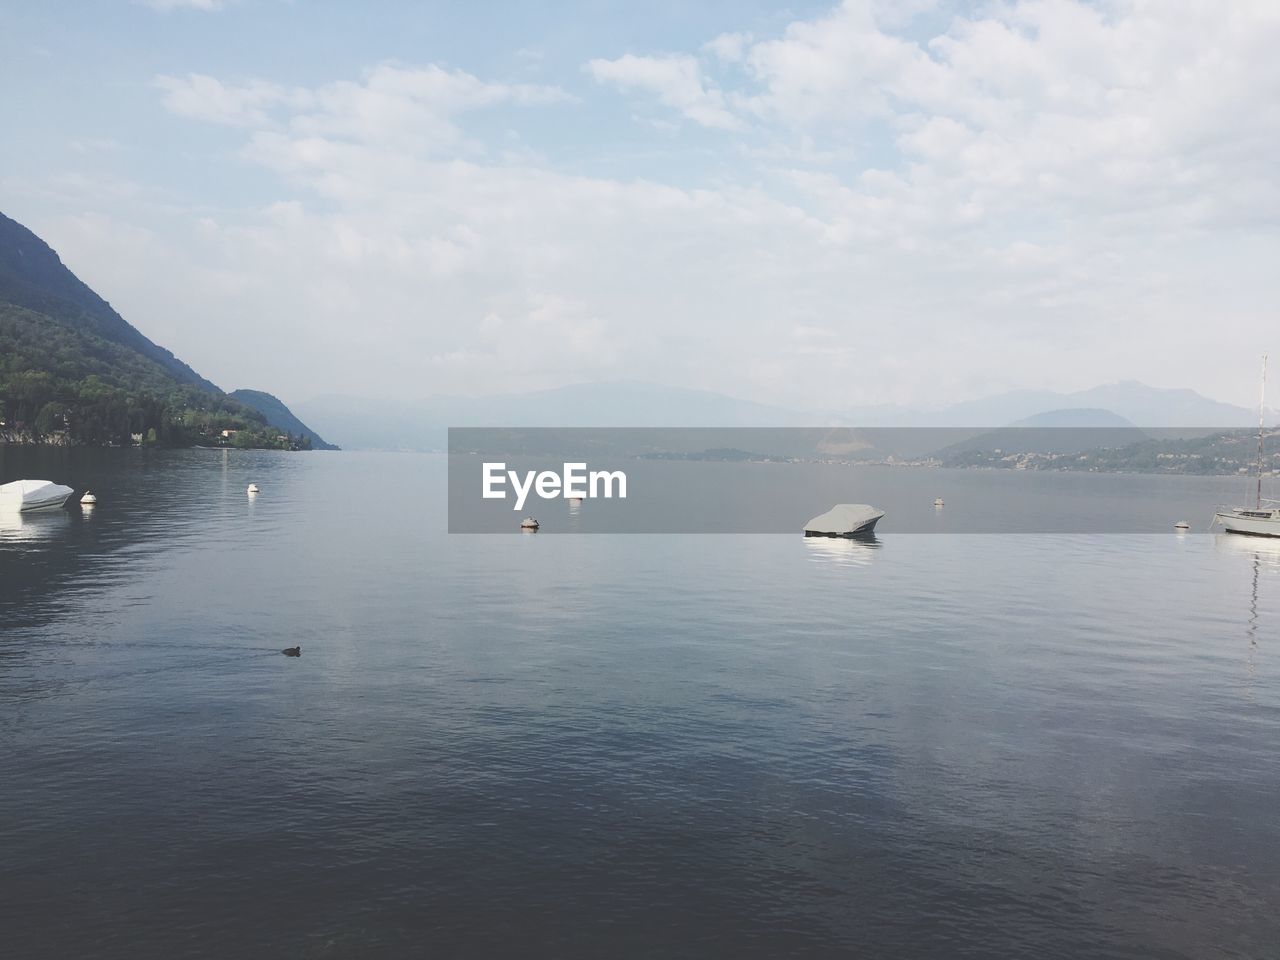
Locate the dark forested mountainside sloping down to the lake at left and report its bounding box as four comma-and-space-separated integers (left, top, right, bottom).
0, 214, 330, 448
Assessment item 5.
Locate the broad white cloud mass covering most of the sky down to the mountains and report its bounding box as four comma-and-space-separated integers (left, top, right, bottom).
27, 0, 1280, 408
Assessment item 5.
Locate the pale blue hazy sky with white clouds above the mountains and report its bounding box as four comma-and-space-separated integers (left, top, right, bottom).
0, 0, 1280, 410
